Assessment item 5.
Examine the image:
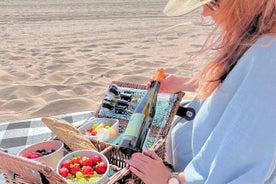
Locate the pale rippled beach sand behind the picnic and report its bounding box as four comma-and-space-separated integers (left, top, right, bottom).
0, 0, 211, 122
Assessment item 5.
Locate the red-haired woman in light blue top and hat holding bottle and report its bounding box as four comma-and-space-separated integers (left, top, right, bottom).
126, 0, 276, 184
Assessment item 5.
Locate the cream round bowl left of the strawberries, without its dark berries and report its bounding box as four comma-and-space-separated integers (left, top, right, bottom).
17, 140, 64, 169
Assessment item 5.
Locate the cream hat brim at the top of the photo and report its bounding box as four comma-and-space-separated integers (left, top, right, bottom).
163, 0, 213, 16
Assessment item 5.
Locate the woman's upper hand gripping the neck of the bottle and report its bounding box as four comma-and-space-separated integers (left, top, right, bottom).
147, 74, 197, 93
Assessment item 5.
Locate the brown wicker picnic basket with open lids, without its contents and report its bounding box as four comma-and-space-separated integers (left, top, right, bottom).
0, 81, 184, 184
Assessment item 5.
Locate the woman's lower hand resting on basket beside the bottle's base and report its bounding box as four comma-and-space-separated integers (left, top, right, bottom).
126, 150, 171, 184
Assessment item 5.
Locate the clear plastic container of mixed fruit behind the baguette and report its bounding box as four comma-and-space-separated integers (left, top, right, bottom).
79, 118, 119, 143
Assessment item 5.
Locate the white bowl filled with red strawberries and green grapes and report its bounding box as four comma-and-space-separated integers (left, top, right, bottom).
56, 150, 109, 184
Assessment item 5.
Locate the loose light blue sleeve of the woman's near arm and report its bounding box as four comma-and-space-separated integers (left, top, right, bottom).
184, 36, 276, 184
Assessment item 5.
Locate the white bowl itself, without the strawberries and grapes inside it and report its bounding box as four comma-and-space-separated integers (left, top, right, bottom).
56, 150, 110, 184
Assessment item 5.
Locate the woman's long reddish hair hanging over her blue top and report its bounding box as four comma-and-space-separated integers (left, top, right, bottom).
198, 0, 276, 99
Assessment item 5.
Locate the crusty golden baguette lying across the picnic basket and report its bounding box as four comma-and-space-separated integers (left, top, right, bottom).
42, 116, 97, 151
